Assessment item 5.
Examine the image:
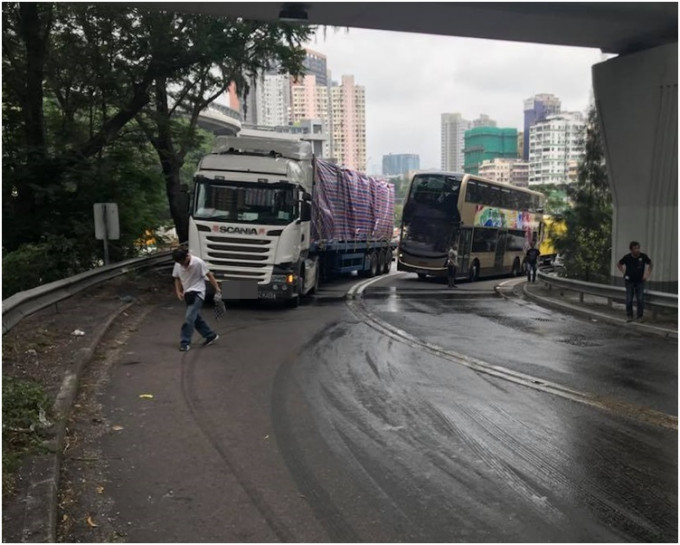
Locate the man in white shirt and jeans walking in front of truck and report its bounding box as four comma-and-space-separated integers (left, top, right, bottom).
172, 248, 222, 352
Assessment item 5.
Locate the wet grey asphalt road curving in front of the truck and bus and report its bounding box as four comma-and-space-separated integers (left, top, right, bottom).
57, 275, 678, 542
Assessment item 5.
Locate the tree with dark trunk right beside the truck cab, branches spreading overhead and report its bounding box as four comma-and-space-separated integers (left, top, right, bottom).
136, 12, 313, 241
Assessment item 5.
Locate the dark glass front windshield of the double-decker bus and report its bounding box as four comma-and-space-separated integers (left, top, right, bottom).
401, 174, 461, 256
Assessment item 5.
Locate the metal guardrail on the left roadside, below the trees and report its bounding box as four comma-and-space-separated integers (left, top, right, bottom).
2, 251, 172, 335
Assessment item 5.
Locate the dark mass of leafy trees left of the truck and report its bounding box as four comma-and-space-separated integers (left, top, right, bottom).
2, 2, 312, 296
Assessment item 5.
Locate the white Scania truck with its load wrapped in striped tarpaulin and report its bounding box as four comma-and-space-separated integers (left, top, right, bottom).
189, 136, 396, 306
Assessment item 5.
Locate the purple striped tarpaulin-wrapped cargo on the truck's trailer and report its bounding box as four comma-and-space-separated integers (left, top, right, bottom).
312, 159, 394, 242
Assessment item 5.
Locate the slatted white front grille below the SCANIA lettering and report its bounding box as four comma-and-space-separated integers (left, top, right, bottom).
205, 235, 272, 282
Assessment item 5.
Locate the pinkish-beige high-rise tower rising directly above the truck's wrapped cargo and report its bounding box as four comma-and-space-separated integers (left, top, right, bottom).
330, 76, 366, 172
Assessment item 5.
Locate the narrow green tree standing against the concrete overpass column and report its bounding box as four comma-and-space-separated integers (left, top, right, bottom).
555, 106, 612, 283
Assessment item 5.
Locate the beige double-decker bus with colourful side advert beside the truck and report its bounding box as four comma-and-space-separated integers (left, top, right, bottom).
397, 172, 545, 280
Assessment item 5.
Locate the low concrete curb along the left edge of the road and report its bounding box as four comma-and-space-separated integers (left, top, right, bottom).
16, 302, 134, 543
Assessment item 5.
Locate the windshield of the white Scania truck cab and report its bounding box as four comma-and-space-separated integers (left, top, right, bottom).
193, 180, 298, 225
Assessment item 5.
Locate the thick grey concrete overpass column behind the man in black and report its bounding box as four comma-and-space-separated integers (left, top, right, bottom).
593, 42, 678, 292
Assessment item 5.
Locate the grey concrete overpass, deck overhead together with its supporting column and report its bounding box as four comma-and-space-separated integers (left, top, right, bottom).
174, 2, 678, 291
